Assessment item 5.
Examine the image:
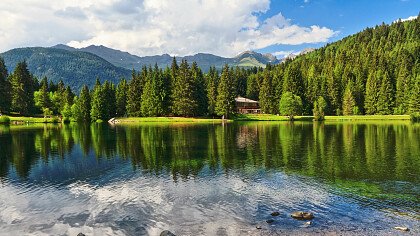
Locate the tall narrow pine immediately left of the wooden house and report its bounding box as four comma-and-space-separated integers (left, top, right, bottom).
215, 64, 236, 118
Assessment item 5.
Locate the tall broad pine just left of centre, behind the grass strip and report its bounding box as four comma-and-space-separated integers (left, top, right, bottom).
172, 60, 198, 116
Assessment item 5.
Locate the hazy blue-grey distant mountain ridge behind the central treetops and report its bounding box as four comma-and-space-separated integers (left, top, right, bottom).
53, 44, 280, 72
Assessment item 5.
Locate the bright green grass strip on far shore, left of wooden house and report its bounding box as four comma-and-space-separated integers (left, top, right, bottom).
116, 117, 226, 123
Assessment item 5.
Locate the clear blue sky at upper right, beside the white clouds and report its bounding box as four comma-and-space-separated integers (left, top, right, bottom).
257, 0, 420, 56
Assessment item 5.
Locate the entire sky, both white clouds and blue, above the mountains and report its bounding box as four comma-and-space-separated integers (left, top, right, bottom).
0, 0, 420, 57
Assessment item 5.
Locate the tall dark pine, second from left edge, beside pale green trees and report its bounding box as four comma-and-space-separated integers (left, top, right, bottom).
10, 61, 34, 115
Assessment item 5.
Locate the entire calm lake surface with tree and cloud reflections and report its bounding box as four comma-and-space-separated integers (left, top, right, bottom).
0, 122, 420, 235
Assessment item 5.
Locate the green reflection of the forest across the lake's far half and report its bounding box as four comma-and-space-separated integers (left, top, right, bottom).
0, 122, 420, 183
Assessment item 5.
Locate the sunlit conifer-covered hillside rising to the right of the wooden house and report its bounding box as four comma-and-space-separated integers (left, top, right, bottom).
264, 17, 420, 115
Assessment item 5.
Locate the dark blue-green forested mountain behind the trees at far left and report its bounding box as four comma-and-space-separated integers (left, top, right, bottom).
0, 45, 131, 91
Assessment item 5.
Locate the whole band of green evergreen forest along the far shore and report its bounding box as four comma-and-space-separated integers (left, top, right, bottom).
0, 17, 420, 121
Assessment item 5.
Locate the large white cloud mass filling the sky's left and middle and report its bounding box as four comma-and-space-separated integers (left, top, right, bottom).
0, 0, 335, 56
